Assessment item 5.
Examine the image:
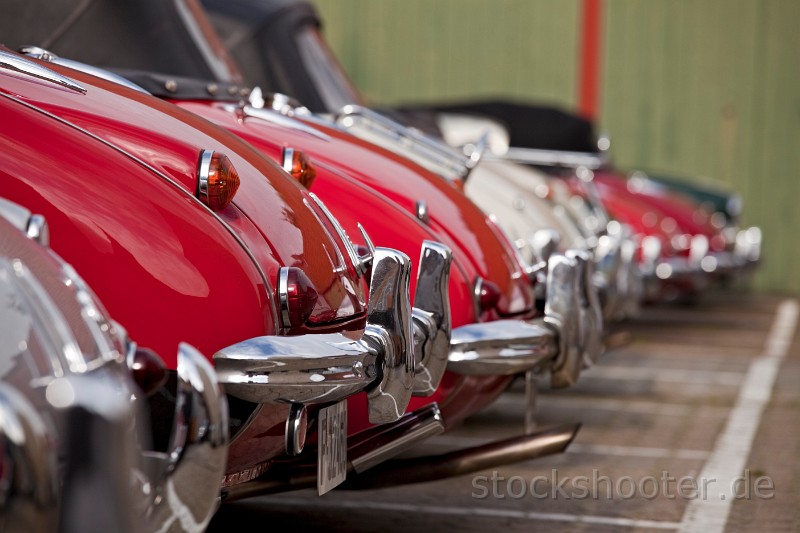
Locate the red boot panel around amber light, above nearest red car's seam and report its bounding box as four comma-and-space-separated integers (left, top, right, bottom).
0, 56, 366, 329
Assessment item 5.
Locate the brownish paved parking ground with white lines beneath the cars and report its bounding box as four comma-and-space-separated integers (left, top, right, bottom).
210, 292, 800, 533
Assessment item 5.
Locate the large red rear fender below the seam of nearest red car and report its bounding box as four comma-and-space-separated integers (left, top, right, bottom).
0, 97, 277, 368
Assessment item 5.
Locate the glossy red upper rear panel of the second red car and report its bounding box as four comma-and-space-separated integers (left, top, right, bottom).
175, 101, 533, 320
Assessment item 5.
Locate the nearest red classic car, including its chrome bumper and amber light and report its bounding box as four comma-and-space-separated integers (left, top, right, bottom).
0, 50, 445, 504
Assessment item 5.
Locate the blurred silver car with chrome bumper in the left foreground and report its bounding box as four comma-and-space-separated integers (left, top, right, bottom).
0, 197, 228, 532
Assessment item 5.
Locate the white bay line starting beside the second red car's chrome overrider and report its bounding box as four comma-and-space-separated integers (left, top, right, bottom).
581, 365, 744, 387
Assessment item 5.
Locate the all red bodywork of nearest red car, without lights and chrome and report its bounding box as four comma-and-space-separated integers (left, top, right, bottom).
0, 57, 382, 477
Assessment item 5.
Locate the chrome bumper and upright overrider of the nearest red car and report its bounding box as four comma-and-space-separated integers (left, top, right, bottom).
214, 248, 415, 423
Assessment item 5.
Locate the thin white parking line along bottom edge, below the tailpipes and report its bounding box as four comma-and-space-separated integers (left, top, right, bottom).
258, 497, 680, 529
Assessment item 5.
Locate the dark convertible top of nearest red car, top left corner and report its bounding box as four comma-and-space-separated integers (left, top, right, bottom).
0, 0, 241, 82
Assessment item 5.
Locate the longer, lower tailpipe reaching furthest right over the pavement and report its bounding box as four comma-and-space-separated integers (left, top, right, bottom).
340, 424, 580, 490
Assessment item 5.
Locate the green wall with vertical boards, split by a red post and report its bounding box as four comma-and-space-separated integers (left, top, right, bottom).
315, 0, 800, 292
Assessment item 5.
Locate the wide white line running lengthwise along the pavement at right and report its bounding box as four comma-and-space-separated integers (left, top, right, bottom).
680, 300, 800, 533
